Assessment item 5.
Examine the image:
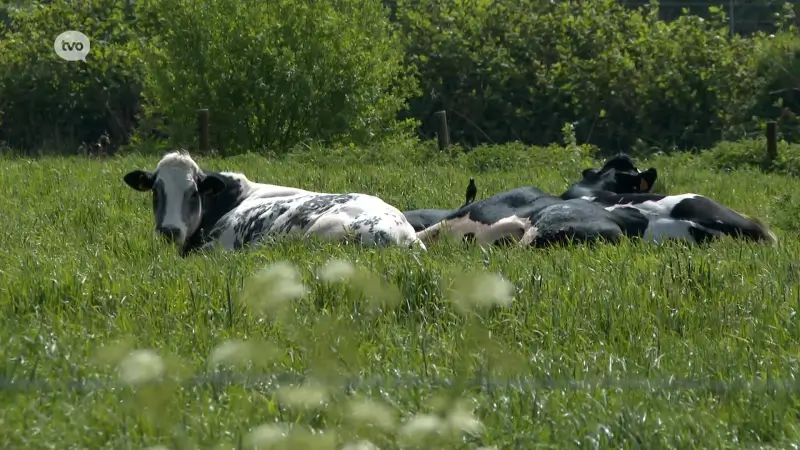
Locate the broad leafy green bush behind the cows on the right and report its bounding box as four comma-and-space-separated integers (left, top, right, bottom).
397, 0, 761, 150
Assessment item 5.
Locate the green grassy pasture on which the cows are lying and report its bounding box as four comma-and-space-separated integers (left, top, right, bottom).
0, 146, 800, 449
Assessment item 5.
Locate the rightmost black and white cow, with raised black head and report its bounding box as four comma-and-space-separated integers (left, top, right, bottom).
561, 154, 778, 244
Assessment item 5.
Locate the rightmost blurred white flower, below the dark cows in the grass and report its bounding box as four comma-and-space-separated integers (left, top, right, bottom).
448, 272, 514, 312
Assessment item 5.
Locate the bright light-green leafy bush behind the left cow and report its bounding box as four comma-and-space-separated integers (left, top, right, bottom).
135, 0, 415, 154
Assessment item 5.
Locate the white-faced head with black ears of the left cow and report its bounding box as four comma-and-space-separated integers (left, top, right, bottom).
123, 152, 225, 247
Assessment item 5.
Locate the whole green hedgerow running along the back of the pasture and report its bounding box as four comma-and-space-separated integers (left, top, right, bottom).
0, 0, 800, 154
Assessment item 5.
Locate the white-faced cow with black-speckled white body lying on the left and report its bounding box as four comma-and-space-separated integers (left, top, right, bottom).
124, 151, 426, 256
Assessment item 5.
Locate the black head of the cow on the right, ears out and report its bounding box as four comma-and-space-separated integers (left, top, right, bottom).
579, 154, 658, 194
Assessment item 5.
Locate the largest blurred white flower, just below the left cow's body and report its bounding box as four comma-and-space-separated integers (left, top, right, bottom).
241, 261, 307, 313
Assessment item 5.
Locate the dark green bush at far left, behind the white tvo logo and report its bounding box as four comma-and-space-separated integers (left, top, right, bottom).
0, 0, 142, 150
